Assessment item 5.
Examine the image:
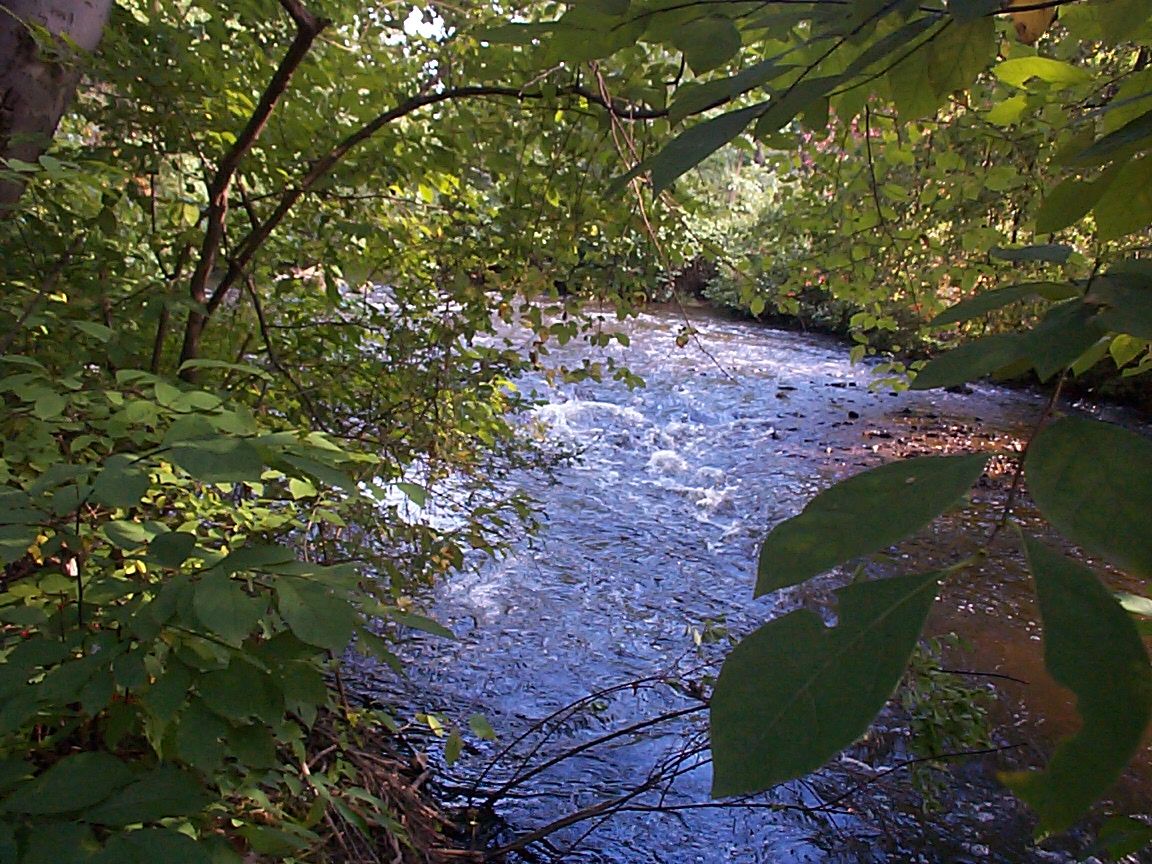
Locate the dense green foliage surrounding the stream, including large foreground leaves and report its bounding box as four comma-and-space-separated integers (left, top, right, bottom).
0, 0, 1152, 863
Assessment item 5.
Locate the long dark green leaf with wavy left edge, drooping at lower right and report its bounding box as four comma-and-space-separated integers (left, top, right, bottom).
1002, 538, 1152, 833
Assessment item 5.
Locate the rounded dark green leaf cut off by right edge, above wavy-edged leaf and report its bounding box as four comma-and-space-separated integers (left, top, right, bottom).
1024, 417, 1152, 578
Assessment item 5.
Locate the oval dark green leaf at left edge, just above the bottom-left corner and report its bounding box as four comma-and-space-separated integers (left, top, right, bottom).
0, 752, 132, 816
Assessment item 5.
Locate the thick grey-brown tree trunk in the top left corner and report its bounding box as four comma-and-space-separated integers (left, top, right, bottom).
0, 0, 112, 218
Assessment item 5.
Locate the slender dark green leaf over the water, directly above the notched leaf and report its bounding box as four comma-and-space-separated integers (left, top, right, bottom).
756, 455, 987, 596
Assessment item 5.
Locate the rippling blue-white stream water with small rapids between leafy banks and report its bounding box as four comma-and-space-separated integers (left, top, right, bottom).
345, 311, 1147, 864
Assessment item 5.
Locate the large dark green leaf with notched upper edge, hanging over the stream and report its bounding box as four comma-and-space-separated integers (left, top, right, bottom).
711, 574, 939, 797
